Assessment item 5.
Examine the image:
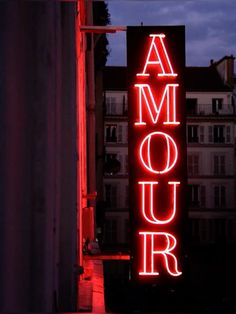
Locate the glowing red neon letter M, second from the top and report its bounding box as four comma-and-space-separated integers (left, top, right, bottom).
135, 84, 180, 125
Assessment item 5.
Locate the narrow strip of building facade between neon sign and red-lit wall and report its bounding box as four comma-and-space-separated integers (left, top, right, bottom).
103, 76, 129, 245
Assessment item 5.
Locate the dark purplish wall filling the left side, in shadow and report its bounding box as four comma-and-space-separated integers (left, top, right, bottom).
0, 1, 77, 312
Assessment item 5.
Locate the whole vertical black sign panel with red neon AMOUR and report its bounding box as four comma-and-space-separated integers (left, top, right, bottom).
127, 26, 186, 282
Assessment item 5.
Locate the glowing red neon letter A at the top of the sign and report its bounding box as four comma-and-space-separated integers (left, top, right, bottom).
137, 34, 177, 76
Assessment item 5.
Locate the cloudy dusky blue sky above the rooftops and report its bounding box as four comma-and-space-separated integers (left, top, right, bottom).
106, 0, 236, 66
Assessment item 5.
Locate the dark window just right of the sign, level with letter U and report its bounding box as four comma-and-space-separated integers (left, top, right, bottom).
188, 184, 206, 208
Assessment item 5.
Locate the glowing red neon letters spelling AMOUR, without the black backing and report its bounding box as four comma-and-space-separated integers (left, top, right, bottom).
134, 34, 181, 276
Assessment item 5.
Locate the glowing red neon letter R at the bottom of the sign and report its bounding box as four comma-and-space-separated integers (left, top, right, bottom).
139, 232, 182, 276
